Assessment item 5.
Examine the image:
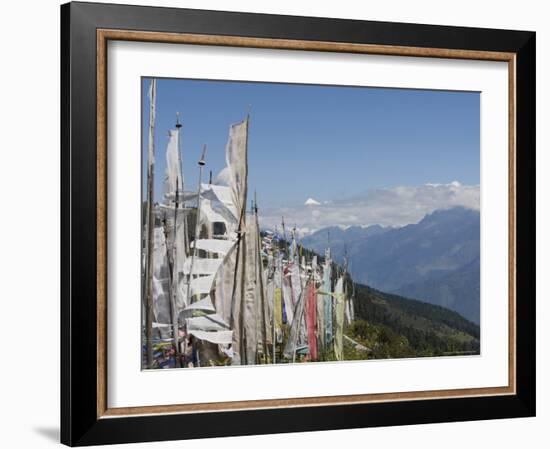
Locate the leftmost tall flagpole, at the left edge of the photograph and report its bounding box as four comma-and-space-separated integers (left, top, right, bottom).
145, 79, 157, 368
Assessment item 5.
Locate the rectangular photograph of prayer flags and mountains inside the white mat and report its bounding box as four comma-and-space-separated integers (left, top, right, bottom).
142, 76, 481, 370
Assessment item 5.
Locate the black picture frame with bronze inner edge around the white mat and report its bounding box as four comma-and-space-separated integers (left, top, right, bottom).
61, 3, 535, 446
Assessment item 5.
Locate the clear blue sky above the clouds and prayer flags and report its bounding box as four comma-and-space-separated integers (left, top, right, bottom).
142, 78, 480, 228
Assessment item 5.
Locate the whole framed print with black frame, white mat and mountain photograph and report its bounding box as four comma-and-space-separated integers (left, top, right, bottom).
61, 3, 535, 446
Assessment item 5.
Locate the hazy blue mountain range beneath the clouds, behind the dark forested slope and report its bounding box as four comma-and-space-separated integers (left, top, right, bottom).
300, 207, 480, 323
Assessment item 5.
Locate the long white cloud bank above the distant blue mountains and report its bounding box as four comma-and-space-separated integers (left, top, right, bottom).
260, 181, 479, 235
